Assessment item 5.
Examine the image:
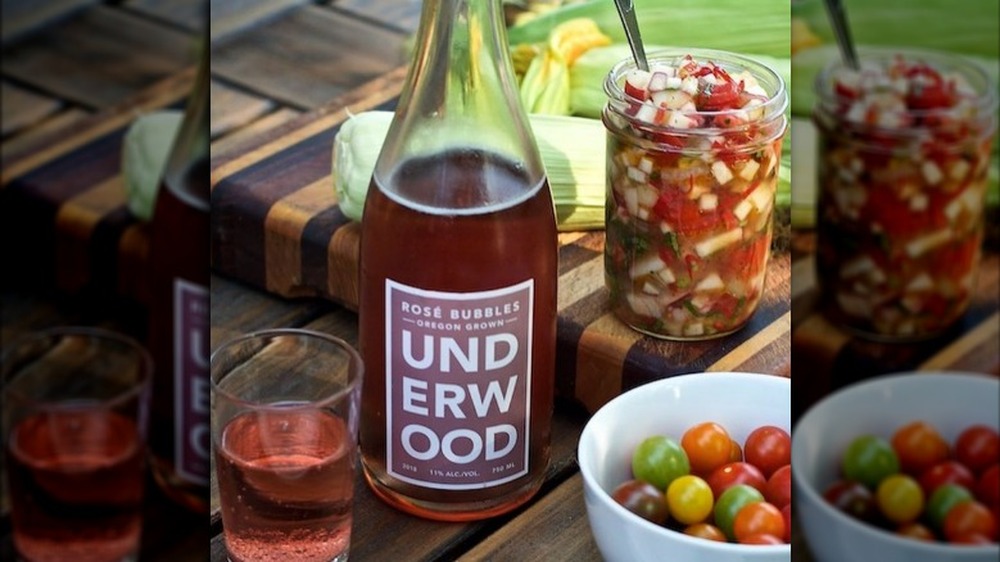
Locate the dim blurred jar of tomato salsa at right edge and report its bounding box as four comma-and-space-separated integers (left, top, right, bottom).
813, 51, 997, 341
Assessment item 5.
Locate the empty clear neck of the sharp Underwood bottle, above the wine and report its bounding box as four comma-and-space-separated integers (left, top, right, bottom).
376, 0, 544, 180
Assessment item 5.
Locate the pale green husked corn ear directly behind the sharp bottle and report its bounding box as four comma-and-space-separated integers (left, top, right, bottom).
332, 111, 605, 230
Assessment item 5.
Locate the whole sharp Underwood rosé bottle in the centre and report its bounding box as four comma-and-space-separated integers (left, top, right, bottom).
359, 0, 558, 521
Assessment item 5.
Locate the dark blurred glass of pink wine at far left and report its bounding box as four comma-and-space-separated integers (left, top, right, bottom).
2, 327, 153, 562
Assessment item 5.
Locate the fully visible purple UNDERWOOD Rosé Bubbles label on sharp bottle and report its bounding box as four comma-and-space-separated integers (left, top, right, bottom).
385, 279, 535, 490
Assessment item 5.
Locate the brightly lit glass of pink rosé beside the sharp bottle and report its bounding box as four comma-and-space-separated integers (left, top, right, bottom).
211, 329, 363, 562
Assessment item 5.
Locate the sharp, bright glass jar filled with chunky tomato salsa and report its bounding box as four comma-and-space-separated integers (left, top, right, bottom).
602, 49, 788, 340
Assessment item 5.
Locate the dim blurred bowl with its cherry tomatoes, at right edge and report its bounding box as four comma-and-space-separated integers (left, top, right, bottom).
792, 372, 1000, 562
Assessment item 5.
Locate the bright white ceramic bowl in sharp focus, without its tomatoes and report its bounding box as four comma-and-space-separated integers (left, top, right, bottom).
577, 373, 791, 562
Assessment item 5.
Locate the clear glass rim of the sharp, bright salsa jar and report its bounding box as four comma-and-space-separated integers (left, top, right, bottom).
604, 47, 788, 127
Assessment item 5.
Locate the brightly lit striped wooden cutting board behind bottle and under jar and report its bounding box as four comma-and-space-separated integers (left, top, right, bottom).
212, 68, 791, 411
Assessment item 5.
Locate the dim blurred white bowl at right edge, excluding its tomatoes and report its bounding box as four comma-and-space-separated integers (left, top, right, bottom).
792, 373, 1000, 562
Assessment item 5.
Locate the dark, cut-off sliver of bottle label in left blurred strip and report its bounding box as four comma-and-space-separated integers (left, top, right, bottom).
174, 279, 212, 484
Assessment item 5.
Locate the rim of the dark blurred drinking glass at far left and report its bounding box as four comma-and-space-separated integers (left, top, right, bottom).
0, 326, 154, 411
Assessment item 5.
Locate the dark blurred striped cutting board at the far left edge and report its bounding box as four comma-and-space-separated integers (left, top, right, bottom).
0, 67, 194, 310
